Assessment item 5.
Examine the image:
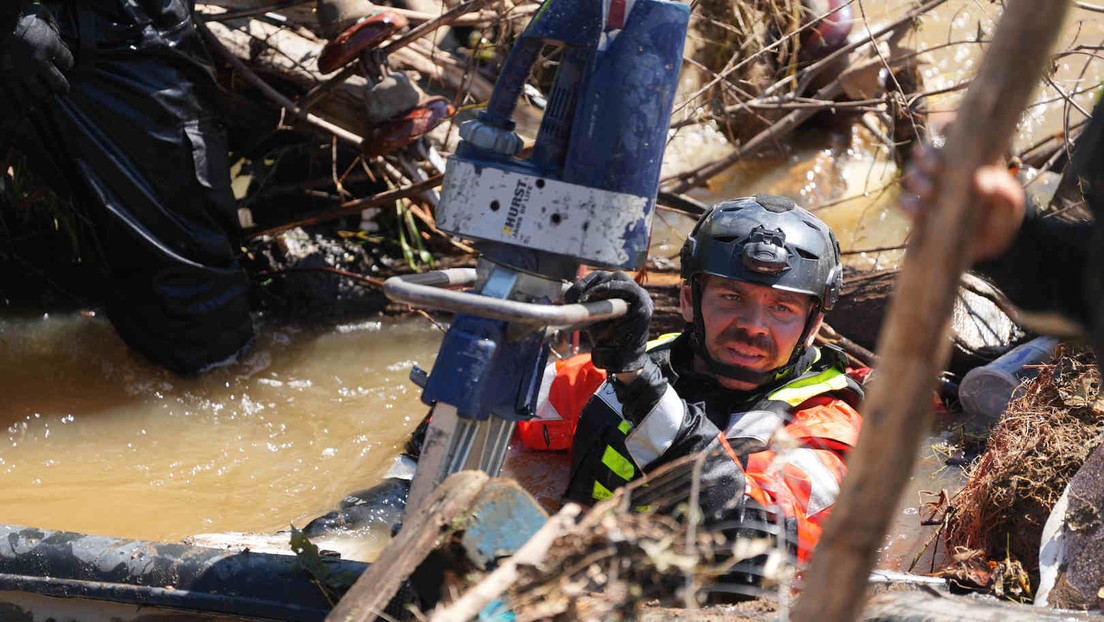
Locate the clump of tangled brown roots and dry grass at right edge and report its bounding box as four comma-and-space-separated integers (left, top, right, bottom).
944, 346, 1104, 584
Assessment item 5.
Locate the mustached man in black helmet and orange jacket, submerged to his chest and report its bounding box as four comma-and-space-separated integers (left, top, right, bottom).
520, 194, 862, 578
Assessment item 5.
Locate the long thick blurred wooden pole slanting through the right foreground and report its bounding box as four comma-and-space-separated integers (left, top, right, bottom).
793, 0, 1069, 621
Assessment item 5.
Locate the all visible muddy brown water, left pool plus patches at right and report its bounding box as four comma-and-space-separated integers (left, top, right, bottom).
0, 1, 1104, 570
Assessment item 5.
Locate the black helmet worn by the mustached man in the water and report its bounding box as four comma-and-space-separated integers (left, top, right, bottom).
680, 194, 843, 310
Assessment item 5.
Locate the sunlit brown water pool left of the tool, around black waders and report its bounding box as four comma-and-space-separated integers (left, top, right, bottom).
0, 315, 440, 540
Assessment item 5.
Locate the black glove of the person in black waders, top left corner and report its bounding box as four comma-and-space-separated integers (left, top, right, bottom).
0, 4, 73, 114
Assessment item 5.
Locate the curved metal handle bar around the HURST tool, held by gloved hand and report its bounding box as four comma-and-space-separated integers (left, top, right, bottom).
383, 267, 628, 327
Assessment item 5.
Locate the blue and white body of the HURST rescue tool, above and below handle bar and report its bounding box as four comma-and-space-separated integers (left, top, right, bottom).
422, 0, 690, 420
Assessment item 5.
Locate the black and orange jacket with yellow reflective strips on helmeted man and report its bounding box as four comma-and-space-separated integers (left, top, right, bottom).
566, 334, 862, 559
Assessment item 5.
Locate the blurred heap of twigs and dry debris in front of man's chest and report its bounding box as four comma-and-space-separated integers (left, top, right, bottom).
490, 457, 793, 620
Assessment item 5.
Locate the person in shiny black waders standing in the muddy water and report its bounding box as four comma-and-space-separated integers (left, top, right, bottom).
0, 0, 253, 373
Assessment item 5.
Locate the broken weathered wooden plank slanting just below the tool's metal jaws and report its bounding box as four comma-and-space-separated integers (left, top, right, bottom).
326, 471, 489, 622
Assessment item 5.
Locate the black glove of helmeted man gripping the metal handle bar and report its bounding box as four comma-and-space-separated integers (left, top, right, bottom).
564, 271, 651, 373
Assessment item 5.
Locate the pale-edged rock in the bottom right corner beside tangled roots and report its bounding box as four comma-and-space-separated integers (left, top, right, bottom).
1036, 445, 1104, 610
